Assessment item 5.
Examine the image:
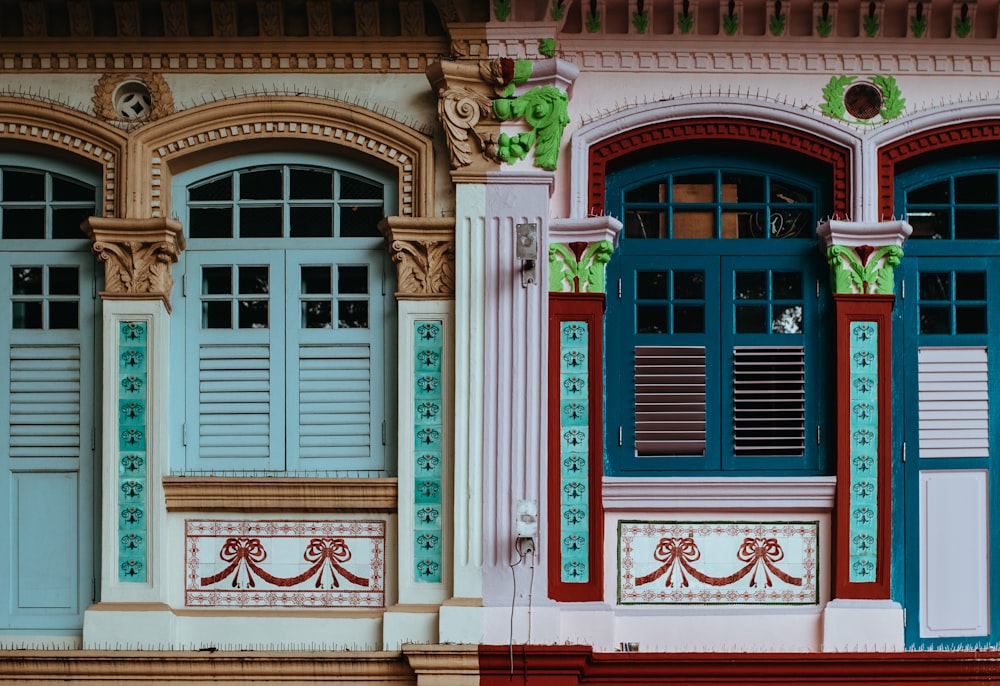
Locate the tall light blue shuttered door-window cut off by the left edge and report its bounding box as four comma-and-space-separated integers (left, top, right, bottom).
0, 153, 100, 634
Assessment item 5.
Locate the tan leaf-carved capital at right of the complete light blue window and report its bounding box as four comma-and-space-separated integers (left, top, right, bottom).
379, 217, 455, 300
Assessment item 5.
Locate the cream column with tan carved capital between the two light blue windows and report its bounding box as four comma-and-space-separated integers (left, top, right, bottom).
83, 217, 184, 647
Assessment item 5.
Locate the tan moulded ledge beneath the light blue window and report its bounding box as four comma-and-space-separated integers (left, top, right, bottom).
163, 476, 396, 512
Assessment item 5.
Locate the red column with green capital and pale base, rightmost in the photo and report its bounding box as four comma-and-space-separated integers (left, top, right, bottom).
817, 220, 912, 650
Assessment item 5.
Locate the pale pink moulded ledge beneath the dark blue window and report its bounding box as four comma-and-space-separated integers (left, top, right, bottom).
602, 476, 837, 512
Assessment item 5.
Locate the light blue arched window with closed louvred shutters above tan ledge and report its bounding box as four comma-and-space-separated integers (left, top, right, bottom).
175, 156, 395, 476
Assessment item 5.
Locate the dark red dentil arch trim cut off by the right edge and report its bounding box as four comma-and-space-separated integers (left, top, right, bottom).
878, 120, 1000, 219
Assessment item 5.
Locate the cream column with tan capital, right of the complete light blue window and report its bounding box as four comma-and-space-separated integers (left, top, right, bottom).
379, 217, 458, 650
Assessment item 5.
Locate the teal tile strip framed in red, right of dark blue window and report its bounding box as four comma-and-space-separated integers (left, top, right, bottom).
850, 321, 879, 583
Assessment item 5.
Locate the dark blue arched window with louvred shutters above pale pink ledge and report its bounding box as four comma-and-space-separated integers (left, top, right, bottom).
606, 155, 829, 475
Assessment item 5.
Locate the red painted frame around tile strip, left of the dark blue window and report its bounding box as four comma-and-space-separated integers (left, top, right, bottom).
546, 293, 604, 602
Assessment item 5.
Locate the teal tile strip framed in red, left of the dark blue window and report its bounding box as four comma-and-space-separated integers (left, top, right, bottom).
559, 321, 590, 583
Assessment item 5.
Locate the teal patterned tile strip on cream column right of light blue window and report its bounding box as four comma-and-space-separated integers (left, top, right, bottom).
413, 321, 444, 583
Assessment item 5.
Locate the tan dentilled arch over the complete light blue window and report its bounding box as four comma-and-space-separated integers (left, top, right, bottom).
129, 96, 434, 217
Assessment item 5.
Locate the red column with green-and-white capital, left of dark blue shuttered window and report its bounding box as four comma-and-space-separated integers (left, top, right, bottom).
546, 217, 621, 602
